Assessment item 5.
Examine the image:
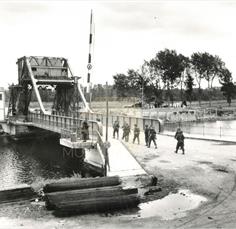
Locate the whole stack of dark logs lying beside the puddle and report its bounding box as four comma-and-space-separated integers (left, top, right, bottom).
44, 176, 139, 216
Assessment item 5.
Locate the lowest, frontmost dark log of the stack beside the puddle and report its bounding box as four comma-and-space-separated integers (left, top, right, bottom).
53, 194, 140, 217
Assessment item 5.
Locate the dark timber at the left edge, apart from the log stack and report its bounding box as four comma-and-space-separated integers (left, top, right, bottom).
0, 185, 36, 203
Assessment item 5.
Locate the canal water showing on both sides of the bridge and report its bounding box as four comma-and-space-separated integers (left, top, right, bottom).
0, 120, 236, 189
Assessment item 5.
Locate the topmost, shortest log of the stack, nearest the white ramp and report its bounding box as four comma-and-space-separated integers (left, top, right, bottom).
43, 176, 121, 193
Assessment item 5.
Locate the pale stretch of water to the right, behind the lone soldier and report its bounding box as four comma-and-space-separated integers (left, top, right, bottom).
165, 120, 236, 138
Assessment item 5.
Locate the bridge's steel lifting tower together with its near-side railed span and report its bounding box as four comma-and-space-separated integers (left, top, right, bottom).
3, 56, 106, 174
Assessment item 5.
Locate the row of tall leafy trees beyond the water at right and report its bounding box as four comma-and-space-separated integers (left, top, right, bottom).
113, 49, 236, 105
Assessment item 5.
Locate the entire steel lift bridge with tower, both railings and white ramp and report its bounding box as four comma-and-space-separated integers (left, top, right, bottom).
1, 56, 160, 175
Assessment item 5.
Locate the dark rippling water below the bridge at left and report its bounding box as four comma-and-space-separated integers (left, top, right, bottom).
0, 136, 85, 188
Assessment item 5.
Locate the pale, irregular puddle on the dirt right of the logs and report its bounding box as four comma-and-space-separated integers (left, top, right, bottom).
138, 190, 207, 220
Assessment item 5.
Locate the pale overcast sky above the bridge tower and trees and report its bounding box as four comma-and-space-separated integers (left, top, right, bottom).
0, 0, 236, 88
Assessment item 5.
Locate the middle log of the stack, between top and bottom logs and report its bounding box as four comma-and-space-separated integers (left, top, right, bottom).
45, 186, 138, 210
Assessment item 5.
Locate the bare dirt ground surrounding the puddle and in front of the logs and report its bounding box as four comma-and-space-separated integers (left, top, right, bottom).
0, 133, 236, 229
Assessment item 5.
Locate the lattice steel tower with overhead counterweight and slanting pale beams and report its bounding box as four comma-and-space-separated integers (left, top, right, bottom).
8, 56, 90, 115
